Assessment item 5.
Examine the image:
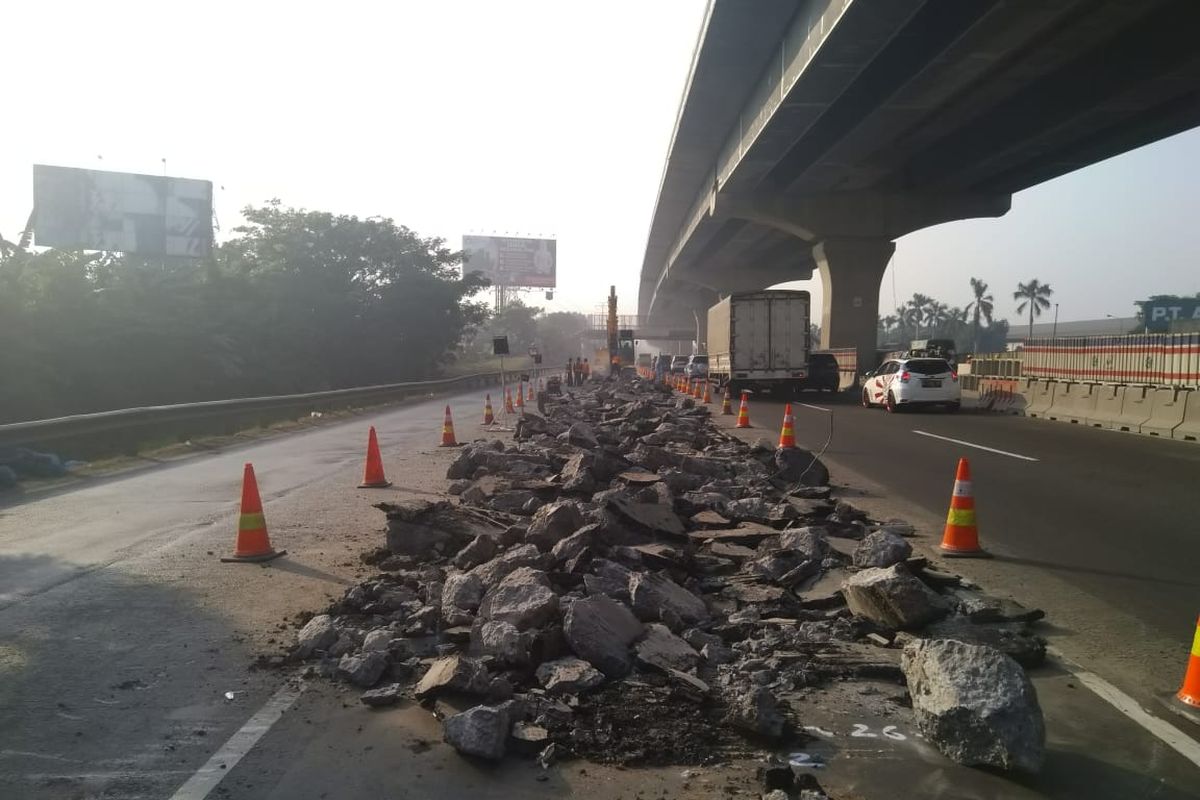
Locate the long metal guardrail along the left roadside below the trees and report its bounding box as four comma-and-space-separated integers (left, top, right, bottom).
0, 367, 559, 446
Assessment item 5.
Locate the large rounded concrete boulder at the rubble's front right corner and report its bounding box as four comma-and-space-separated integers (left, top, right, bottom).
900, 639, 1045, 772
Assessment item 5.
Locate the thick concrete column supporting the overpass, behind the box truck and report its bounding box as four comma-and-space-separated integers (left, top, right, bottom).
812, 237, 896, 374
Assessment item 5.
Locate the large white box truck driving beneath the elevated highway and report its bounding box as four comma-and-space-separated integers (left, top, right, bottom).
708, 289, 811, 396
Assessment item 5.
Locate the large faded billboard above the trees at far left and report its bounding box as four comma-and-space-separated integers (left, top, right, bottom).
34, 164, 212, 258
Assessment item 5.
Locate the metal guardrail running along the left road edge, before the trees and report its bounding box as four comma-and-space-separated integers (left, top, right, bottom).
0, 367, 560, 456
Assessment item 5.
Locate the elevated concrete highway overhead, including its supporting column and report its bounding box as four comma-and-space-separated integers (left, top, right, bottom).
638, 0, 1200, 363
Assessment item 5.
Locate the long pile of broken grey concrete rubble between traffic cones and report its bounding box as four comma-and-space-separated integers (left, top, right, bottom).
285, 379, 1045, 771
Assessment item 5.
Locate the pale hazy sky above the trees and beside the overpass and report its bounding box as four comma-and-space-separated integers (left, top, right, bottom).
0, 0, 1200, 320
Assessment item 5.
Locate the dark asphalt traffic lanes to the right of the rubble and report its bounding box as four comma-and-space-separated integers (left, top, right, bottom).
714, 393, 1200, 703
